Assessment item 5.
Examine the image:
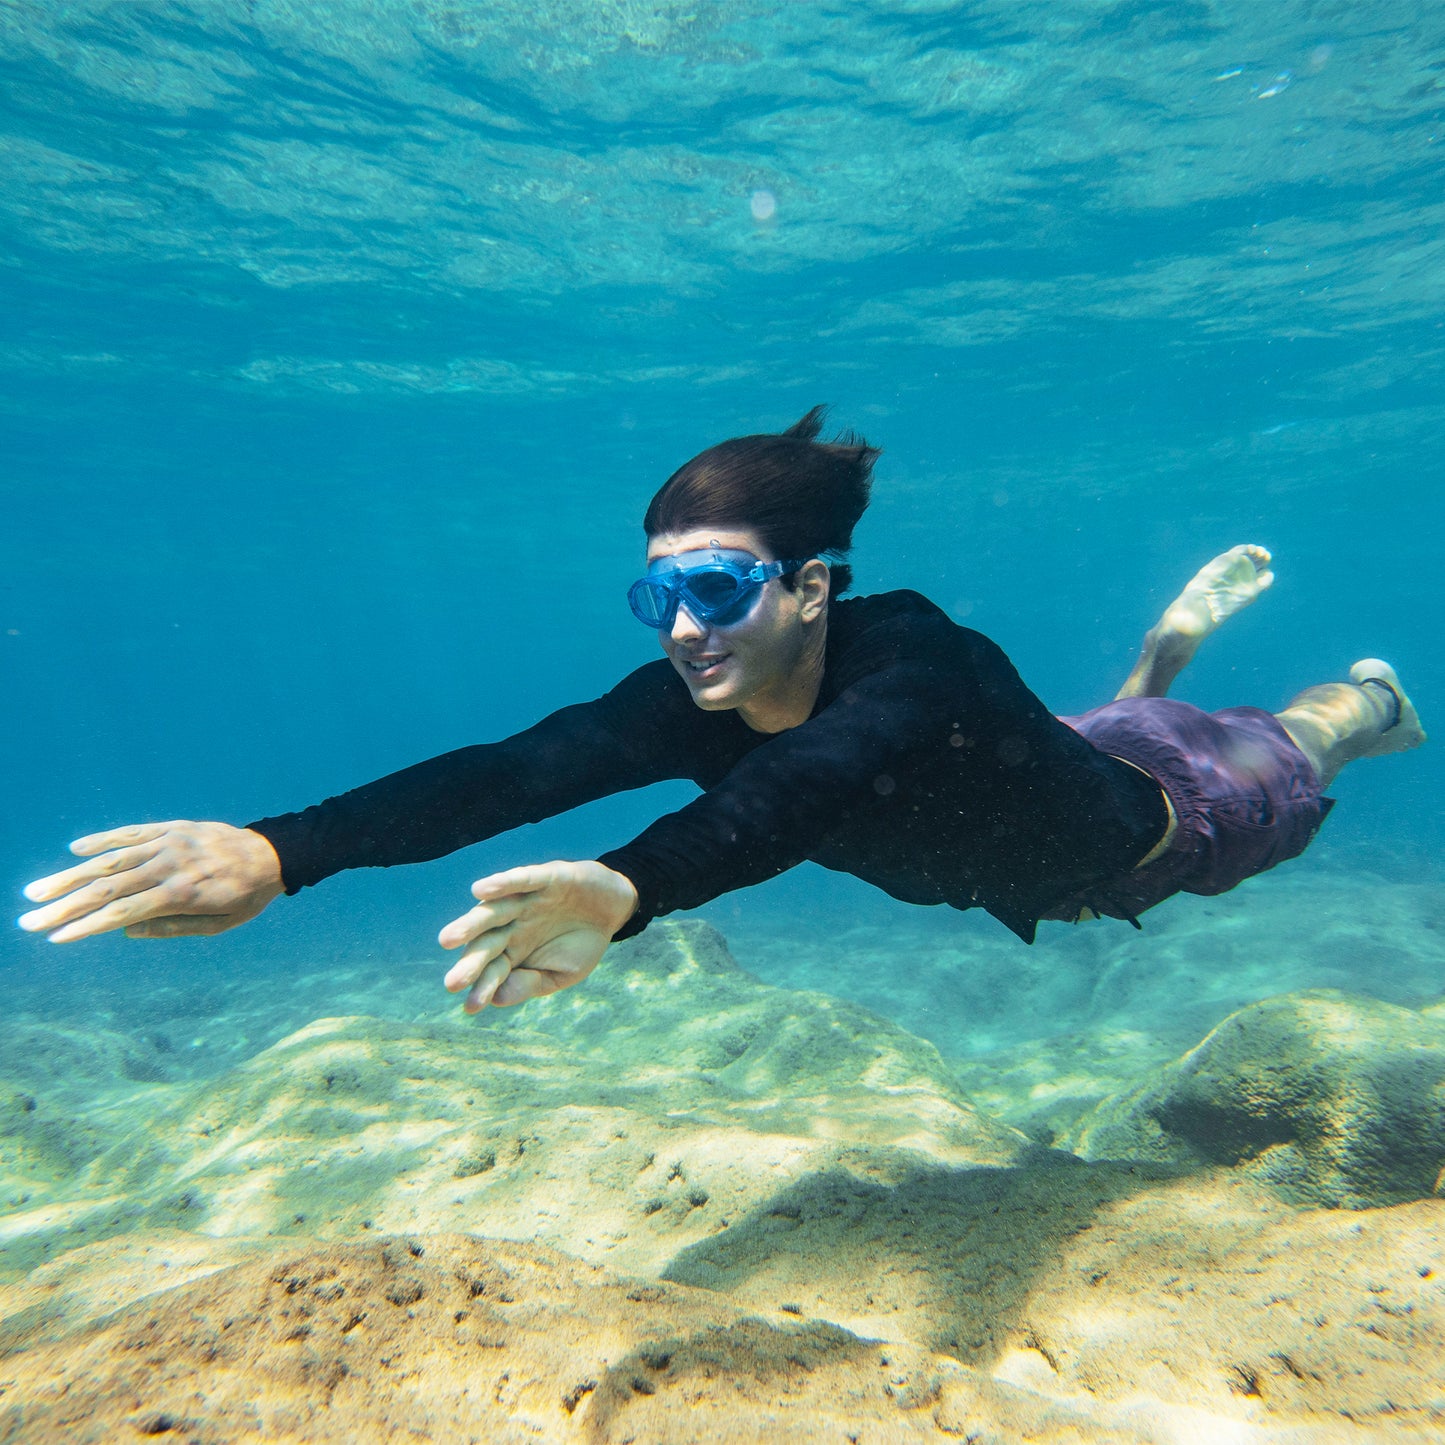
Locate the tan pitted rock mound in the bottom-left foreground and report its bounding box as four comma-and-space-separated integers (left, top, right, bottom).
0, 1235, 964, 1445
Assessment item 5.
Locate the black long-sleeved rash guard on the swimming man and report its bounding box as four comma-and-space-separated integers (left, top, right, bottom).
249, 592, 1168, 942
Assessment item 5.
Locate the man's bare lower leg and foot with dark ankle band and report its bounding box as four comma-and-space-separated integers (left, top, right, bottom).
1274, 657, 1425, 788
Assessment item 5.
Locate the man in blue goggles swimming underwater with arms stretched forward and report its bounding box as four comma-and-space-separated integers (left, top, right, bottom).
20, 407, 1425, 1012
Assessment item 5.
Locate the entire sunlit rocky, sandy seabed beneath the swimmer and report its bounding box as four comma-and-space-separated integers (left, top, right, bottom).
0, 861, 1445, 1445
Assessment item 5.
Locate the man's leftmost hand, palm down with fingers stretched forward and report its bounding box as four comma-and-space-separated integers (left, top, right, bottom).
19, 821, 283, 944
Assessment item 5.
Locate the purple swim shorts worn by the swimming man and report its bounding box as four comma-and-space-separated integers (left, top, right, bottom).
1049, 698, 1334, 918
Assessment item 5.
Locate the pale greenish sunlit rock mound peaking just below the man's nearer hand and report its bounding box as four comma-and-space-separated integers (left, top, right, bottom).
0, 923, 1038, 1270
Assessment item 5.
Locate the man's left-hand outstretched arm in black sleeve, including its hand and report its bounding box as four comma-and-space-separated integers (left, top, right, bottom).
19, 662, 692, 944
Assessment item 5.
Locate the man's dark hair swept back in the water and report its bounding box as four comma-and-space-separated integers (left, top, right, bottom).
643, 406, 879, 597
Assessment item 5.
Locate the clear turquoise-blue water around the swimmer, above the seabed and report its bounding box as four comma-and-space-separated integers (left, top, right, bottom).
0, 0, 1445, 1080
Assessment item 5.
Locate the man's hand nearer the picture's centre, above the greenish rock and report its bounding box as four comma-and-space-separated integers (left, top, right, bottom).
438, 863, 637, 1013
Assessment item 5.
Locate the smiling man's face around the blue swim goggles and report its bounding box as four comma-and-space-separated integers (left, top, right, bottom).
647, 529, 805, 721
